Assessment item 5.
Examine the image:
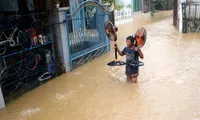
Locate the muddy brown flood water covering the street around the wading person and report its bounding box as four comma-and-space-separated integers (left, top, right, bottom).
0, 11, 200, 120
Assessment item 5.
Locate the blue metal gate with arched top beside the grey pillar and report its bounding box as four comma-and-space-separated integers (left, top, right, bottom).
66, 1, 110, 70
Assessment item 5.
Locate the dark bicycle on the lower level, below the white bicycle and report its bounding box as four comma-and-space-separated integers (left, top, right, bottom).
0, 52, 38, 95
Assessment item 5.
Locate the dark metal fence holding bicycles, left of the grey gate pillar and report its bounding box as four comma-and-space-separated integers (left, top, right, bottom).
0, 13, 55, 103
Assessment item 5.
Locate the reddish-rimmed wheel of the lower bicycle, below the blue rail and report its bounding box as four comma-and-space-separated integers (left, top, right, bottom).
24, 52, 38, 70
